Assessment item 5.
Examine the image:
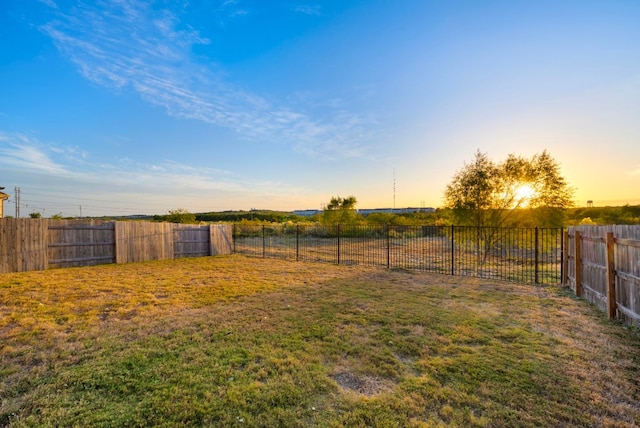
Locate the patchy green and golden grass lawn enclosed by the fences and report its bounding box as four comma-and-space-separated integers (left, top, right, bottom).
0, 255, 640, 427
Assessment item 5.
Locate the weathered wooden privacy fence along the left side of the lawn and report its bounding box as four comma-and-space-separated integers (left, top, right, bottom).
0, 218, 233, 273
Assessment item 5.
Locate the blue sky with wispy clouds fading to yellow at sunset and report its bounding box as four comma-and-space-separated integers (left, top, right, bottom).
0, 0, 640, 217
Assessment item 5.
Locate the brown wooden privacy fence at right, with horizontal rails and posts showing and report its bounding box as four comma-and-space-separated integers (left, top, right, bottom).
563, 226, 640, 326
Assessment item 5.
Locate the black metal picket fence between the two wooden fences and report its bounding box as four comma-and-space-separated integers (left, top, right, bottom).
233, 223, 564, 284
